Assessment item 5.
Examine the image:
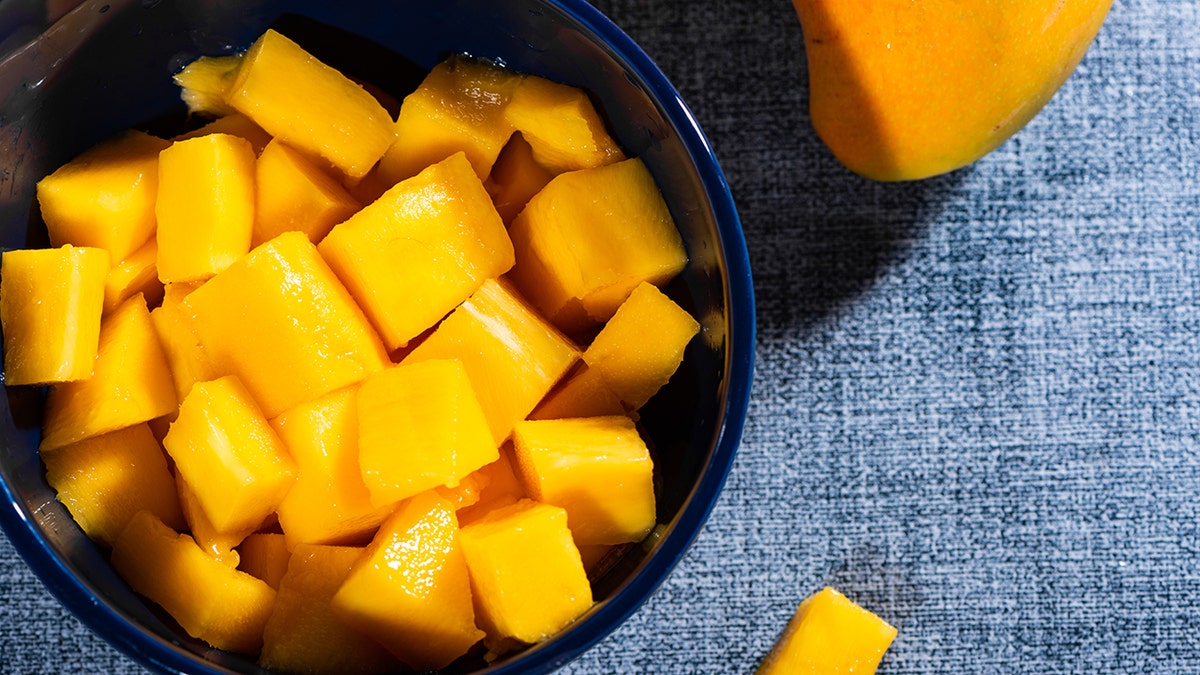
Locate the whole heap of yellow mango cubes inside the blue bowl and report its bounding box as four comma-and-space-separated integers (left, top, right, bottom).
0, 30, 700, 673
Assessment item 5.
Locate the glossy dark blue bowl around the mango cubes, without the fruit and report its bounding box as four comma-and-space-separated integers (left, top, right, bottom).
0, 0, 755, 674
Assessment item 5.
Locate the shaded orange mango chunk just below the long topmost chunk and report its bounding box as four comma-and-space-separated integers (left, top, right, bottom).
252, 141, 359, 246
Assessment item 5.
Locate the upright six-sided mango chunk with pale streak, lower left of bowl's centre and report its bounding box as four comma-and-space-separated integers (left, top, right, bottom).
163, 376, 295, 542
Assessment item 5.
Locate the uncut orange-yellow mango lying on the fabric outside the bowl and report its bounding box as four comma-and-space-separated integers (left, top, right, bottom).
793, 0, 1112, 181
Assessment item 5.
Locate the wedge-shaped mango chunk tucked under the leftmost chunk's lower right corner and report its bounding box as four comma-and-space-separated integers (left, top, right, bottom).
38, 295, 179, 452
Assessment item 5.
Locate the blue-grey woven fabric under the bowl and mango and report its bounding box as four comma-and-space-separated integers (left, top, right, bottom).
0, 0, 1200, 675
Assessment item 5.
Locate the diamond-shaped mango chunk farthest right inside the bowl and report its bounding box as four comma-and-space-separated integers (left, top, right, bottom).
583, 282, 700, 410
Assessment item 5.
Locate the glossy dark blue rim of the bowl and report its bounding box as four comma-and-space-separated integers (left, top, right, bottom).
0, 0, 756, 675
